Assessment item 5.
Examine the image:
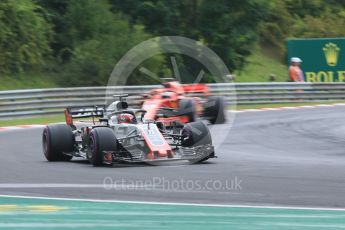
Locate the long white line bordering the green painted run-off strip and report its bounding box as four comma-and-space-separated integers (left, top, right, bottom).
0, 195, 345, 211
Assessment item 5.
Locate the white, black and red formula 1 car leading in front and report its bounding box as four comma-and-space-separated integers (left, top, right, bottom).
42, 96, 215, 166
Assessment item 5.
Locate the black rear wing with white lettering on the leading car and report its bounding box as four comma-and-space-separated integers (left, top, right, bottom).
65, 105, 105, 125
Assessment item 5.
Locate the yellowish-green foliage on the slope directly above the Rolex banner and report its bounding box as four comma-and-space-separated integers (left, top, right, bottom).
259, 0, 345, 59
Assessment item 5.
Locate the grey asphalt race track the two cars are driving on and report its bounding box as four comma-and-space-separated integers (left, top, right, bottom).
0, 106, 345, 208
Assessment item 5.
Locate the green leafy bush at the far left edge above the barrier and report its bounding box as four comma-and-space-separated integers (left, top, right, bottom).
0, 0, 52, 73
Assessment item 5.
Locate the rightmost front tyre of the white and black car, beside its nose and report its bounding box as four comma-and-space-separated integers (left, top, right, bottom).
182, 121, 214, 163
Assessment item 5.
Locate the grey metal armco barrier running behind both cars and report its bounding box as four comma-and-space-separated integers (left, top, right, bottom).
0, 82, 345, 119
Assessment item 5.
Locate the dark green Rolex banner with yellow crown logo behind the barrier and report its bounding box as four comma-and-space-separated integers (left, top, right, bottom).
287, 38, 345, 82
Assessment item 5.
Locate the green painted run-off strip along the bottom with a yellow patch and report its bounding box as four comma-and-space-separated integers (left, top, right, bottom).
0, 197, 345, 230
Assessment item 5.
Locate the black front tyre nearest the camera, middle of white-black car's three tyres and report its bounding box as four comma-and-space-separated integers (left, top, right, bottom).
88, 127, 117, 166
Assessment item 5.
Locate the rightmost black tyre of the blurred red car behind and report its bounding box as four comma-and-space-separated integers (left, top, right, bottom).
204, 96, 226, 124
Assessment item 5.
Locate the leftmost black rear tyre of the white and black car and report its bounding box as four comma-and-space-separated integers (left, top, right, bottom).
42, 124, 75, 161
